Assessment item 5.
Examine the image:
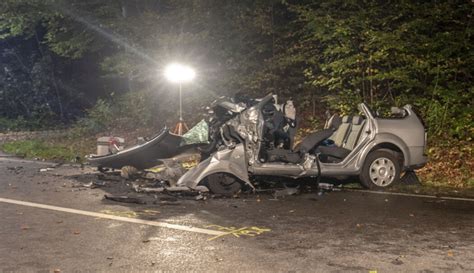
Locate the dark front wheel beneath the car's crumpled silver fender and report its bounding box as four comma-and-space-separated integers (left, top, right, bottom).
204, 173, 242, 196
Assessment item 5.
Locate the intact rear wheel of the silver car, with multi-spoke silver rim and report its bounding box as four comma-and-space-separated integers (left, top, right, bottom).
359, 149, 401, 190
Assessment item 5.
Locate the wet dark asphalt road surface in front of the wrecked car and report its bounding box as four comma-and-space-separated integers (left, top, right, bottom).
0, 157, 474, 272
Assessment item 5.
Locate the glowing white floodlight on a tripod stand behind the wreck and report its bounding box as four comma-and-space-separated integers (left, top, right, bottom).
165, 63, 196, 135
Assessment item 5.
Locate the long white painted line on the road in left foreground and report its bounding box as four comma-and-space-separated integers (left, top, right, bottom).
0, 198, 225, 236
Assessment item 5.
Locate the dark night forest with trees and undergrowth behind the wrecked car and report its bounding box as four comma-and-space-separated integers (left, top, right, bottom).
0, 0, 474, 188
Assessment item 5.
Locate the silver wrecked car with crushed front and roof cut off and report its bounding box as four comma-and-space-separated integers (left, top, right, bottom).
178, 94, 427, 194
